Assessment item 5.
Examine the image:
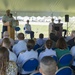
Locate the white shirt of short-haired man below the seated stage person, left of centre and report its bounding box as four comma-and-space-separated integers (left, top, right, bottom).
12, 40, 27, 55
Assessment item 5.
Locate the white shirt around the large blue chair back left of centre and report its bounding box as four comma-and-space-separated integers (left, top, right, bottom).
17, 49, 38, 74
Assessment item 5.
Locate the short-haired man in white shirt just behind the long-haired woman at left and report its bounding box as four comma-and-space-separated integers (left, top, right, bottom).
2, 38, 17, 62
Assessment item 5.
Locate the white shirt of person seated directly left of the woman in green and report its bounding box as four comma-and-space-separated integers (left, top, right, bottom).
39, 48, 56, 60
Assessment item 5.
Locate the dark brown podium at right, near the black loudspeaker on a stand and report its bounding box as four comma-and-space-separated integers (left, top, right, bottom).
52, 23, 63, 37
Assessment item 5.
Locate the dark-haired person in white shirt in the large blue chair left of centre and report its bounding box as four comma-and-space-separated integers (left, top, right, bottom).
17, 40, 38, 75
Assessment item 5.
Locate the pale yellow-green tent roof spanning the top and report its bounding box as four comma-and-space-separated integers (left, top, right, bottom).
0, 0, 75, 16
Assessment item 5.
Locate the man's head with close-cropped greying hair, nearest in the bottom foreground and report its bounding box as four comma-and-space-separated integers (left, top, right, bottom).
39, 56, 57, 75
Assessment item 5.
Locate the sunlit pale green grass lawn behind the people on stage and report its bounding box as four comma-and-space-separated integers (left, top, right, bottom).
0, 23, 75, 39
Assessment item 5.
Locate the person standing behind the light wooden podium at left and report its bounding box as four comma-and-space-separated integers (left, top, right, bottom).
2, 9, 10, 34
